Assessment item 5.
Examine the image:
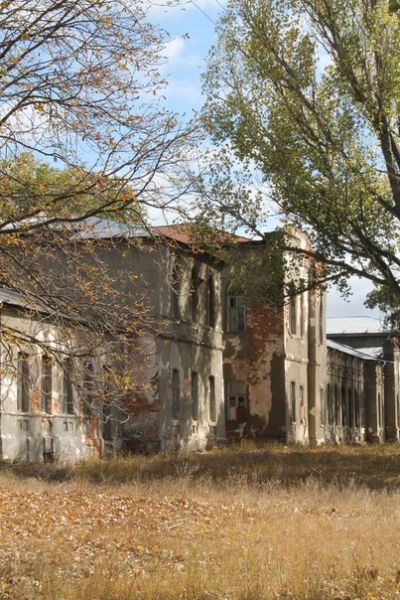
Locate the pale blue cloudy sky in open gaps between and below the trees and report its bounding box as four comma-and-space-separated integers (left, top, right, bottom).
150, 0, 380, 318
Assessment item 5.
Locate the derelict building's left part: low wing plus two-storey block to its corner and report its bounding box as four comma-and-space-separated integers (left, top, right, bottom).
1, 219, 225, 460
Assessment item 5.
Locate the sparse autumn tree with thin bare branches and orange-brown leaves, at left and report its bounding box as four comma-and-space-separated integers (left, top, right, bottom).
0, 0, 189, 412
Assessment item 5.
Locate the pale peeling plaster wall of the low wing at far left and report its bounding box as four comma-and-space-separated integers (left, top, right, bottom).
0, 306, 94, 462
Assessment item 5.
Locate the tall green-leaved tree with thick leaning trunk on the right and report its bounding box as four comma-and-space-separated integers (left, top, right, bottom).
203, 0, 400, 326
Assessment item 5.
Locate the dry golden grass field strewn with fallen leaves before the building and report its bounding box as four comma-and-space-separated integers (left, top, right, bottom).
0, 445, 400, 600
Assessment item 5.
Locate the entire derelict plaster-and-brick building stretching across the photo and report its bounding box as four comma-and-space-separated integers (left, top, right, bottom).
0, 219, 400, 460
